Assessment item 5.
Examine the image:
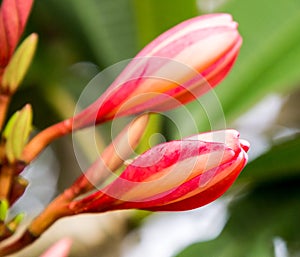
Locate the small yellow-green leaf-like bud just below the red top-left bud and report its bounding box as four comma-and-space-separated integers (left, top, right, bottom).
2, 34, 38, 93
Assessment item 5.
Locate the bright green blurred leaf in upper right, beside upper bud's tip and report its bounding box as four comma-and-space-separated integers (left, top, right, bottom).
217, 0, 300, 121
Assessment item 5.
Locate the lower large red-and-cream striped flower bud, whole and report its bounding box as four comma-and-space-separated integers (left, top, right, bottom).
71, 130, 249, 212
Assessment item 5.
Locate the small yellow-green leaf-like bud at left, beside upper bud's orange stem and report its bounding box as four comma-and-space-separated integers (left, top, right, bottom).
3, 104, 32, 163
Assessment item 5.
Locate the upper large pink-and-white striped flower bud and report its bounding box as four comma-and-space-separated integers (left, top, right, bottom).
73, 14, 242, 129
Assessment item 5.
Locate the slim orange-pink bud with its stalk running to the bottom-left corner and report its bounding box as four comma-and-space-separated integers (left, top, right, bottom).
0, 114, 148, 256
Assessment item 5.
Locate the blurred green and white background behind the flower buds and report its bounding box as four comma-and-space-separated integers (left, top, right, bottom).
6, 0, 300, 257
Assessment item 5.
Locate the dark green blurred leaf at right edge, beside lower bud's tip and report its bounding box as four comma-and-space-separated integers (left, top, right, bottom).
240, 135, 300, 182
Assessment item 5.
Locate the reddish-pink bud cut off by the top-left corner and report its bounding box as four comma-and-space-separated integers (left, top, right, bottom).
0, 0, 33, 69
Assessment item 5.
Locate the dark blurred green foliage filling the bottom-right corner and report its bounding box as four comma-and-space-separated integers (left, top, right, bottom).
177, 181, 300, 257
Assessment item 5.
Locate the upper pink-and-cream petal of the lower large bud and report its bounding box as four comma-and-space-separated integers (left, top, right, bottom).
73, 140, 234, 209
